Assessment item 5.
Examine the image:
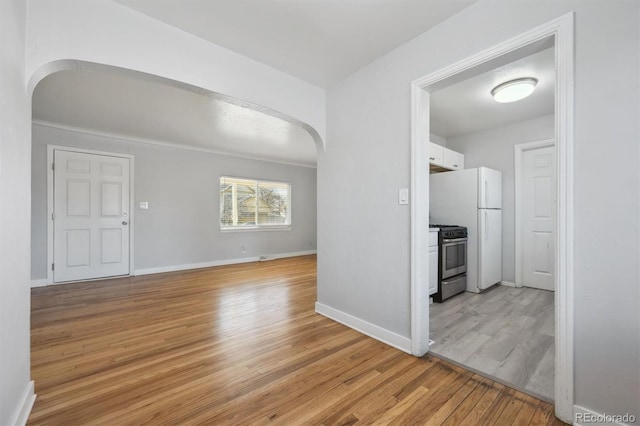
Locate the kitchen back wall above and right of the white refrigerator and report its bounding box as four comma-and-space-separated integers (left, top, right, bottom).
447, 114, 554, 283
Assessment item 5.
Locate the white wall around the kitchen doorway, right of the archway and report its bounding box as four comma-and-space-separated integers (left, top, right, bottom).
318, 0, 640, 416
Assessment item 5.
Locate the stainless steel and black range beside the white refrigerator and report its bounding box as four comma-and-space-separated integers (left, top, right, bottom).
429, 225, 467, 303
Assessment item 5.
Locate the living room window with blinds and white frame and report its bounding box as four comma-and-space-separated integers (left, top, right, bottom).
220, 176, 291, 229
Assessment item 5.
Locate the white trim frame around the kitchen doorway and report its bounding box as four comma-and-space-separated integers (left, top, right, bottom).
411, 13, 574, 421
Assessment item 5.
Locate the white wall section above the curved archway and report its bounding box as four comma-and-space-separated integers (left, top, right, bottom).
26, 0, 326, 146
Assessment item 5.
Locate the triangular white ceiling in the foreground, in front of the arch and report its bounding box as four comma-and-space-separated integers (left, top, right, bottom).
115, 0, 477, 88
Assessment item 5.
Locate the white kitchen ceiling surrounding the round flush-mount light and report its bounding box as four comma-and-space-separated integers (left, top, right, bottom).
430, 48, 555, 139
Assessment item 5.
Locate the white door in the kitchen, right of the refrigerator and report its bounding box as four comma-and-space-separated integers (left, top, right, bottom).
521, 146, 556, 291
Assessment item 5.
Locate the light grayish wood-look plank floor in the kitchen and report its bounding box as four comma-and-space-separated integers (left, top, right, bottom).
429, 285, 555, 401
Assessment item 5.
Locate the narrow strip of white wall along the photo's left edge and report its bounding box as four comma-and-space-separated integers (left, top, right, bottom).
0, 0, 33, 425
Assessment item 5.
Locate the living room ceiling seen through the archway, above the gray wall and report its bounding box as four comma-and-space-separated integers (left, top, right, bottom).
33, 71, 316, 167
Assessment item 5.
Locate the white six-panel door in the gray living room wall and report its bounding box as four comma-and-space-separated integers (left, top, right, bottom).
53, 149, 130, 282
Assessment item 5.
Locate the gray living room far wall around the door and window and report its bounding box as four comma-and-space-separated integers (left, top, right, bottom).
31, 125, 316, 279
